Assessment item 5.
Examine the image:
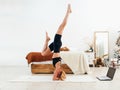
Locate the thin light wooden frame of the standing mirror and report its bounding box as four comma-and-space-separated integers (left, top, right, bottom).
94, 31, 109, 59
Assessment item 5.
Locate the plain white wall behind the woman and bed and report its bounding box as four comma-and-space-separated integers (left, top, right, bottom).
0, 0, 120, 65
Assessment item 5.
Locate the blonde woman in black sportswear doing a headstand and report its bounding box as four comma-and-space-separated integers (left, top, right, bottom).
41, 4, 71, 80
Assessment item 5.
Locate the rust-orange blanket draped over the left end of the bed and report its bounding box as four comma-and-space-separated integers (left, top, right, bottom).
26, 52, 53, 64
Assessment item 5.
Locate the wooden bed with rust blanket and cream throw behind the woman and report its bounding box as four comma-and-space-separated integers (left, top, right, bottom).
26, 51, 90, 74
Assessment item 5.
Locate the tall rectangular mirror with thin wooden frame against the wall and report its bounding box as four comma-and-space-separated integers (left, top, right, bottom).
94, 31, 109, 58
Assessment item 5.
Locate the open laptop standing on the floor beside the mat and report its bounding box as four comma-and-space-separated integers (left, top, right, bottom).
96, 67, 116, 81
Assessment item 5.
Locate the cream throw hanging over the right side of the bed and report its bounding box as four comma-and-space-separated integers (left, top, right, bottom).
61, 51, 90, 74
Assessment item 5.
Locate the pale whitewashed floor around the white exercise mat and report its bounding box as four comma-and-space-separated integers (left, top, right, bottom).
0, 66, 120, 90
